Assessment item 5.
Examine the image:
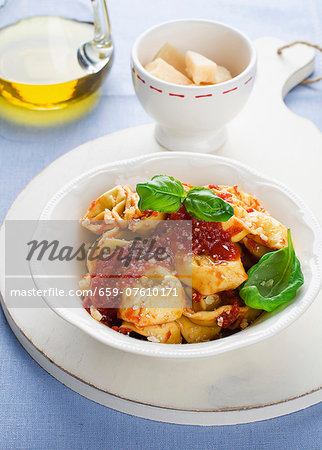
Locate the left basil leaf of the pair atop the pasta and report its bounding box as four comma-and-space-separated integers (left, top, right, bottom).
136, 175, 186, 213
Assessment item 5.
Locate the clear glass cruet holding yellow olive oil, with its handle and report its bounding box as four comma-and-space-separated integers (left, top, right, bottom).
0, 0, 113, 110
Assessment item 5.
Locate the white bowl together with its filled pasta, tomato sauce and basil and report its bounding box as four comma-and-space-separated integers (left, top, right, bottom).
38, 152, 322, 358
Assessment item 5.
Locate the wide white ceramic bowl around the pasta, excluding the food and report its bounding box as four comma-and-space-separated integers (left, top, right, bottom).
40, 153, 322, 358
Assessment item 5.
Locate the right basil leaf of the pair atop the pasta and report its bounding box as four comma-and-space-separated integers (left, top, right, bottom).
184, 186, 234, 222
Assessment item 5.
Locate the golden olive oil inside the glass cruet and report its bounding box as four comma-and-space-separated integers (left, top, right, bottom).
0, 16, 110, 110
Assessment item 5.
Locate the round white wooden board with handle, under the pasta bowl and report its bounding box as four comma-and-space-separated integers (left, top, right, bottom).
0, 38, 322, 425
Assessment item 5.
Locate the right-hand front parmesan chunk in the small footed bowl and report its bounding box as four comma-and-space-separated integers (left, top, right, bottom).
186, 50, 217, 84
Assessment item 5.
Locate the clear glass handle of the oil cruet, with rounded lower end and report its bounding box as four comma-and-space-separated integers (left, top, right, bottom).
77, 0, 114, 72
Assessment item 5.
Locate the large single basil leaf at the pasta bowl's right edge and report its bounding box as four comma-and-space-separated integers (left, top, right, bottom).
239, 230, 304, 311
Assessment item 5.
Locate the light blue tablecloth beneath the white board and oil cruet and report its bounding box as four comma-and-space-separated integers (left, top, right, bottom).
0, 0, 322, 449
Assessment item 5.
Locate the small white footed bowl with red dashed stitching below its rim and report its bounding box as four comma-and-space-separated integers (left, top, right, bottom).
132, 19, 256, 152
